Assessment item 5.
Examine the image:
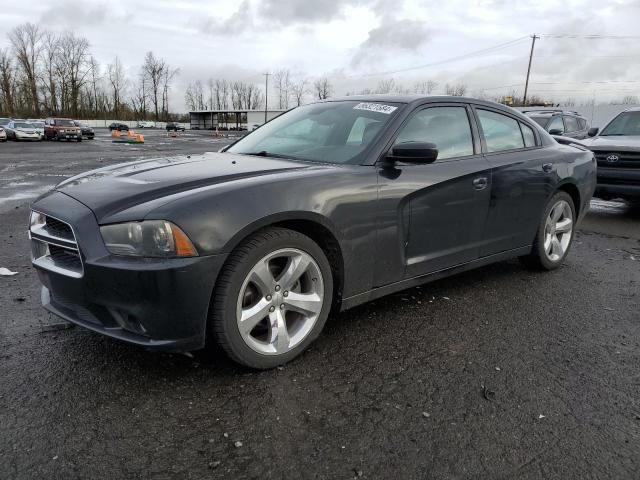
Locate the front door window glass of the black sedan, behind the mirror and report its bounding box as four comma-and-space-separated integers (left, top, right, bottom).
395, 107, 473, 160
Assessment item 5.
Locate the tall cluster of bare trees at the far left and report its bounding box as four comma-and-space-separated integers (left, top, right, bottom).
0, 23, 179, 120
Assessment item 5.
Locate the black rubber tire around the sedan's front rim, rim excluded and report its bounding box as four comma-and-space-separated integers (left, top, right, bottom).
208, 227, 333, 370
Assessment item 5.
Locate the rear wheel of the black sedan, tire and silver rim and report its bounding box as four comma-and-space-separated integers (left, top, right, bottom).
521, 192, 576, 270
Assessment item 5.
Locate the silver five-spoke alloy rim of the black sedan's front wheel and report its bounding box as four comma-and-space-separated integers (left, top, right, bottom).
236, 248, 324, 355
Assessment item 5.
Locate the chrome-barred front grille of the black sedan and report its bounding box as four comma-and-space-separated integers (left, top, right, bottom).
29, 215, 84, 278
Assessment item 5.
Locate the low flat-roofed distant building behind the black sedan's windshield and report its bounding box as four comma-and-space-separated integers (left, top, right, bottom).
189, 110, 286, 130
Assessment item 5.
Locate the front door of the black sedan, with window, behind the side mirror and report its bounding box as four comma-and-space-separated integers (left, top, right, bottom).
378, 103, 491, 278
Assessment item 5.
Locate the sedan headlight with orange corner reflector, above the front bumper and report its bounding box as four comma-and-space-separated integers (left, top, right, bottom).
100, 220, 198, 257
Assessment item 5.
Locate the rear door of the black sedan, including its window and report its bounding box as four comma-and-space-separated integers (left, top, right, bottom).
474, 106, 562, 257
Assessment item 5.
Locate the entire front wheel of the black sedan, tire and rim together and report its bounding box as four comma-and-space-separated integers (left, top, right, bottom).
209, 228, 333, 369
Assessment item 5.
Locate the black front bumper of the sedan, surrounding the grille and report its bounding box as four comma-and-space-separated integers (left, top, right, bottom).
33, 192, 226, 351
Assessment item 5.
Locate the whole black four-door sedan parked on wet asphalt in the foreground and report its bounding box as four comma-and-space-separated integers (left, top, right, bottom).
30, 96, 596, 368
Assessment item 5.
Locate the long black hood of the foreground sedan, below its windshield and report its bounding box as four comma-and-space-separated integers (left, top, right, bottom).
55, 153, 326, 221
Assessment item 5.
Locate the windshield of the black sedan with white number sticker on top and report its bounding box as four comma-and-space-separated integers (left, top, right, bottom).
227, 101, 400, 163
